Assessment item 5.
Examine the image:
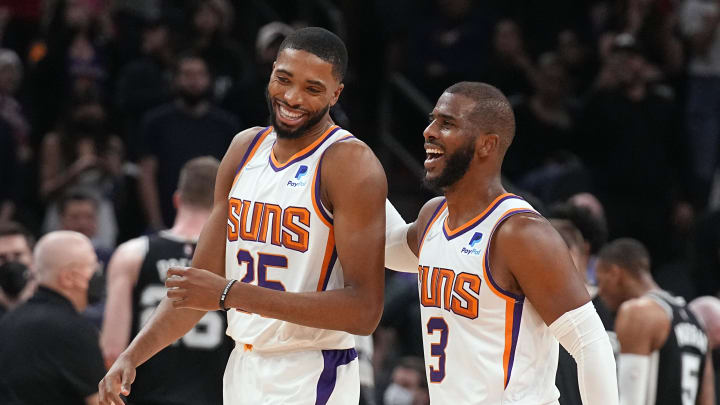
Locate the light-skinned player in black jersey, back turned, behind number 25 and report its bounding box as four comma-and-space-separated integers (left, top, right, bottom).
100, 157, 232, 405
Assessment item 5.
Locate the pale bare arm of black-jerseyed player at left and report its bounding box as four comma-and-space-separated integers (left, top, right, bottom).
100, 238, 146, 368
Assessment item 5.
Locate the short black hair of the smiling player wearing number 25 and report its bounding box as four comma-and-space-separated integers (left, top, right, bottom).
278, 27, 347, 82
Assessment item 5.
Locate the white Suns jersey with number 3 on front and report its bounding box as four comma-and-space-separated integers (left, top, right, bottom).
418, 194, 559, 405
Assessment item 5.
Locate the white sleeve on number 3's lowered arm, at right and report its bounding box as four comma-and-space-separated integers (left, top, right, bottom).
550, 302, 620, 405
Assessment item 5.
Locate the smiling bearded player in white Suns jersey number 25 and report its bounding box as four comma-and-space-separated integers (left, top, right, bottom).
100, 28, 387, 405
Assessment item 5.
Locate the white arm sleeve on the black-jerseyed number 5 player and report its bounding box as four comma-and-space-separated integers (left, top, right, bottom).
618, 353, 651, 405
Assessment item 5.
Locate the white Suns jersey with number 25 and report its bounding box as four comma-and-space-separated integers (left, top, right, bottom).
225, 126, 355, 352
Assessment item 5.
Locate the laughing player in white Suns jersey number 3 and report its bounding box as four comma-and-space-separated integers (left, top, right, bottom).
386, 82, 618, 405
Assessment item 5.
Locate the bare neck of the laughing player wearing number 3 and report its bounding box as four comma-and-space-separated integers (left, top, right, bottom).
444, 172, 506, 229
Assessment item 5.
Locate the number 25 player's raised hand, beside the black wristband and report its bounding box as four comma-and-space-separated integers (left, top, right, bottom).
165, 267, 228, 311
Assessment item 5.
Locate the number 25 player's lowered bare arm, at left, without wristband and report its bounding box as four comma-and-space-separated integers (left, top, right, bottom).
98, 128, 259, 405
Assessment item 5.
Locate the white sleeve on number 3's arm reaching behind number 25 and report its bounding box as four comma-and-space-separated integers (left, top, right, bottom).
385, 200, 418, 273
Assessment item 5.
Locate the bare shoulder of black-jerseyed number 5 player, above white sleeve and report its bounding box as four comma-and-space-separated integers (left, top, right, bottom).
615, 297, 670, 354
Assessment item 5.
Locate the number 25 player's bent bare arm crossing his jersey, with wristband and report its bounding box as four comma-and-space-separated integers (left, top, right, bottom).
166, 140, 387, 334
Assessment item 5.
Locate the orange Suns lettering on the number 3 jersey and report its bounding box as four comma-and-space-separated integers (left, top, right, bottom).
418, 265, 481, 319
